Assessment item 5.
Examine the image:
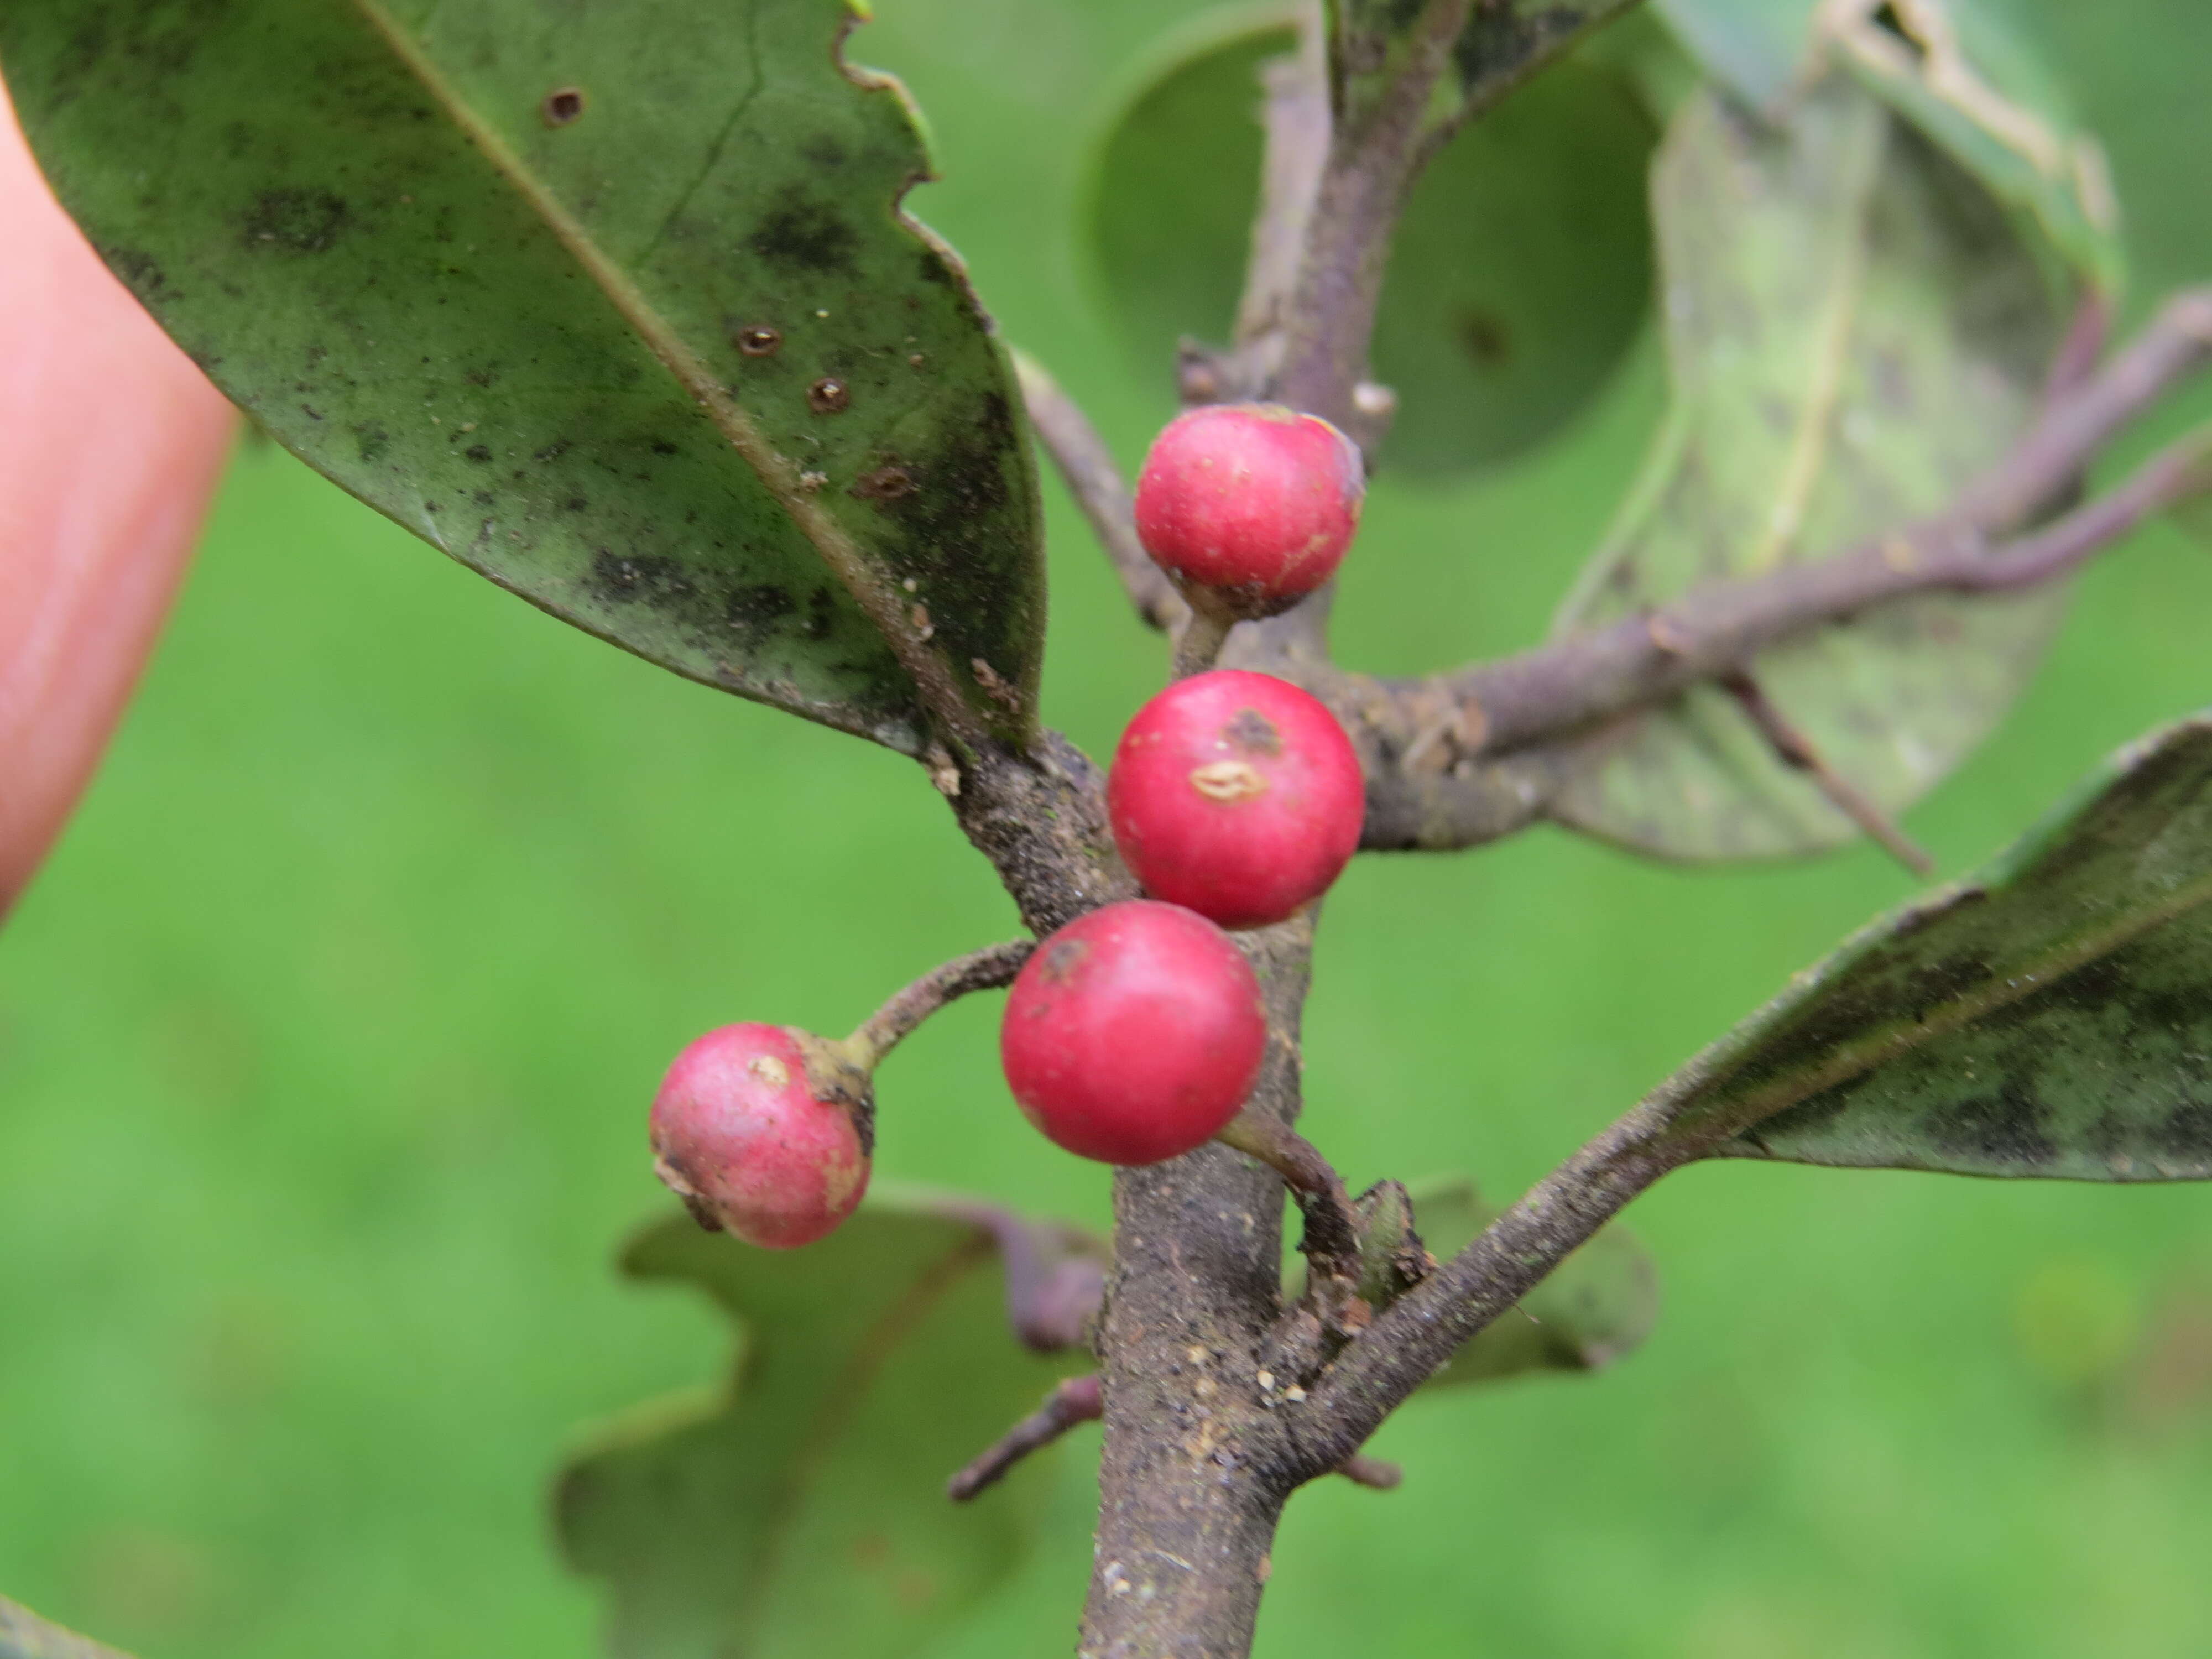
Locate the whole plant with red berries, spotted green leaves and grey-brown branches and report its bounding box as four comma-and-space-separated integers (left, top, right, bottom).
0, 0, 2212, 1659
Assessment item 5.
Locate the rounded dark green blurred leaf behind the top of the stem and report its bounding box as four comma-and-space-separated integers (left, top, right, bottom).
1086, 13, 1655, 476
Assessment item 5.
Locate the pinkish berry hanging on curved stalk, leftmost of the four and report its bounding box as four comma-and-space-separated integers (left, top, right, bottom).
653, 1024, 869, 1250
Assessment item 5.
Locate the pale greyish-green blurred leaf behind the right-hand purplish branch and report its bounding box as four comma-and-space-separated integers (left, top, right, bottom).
1555, 77, 2066, 858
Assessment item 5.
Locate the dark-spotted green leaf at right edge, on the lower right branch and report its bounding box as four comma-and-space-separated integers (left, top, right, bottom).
1655, 712, 2212, 1181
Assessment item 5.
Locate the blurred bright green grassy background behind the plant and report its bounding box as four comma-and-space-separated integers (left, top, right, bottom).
0, 0, 2212, 1659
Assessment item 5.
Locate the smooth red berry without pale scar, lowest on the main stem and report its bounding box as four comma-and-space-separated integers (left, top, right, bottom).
998, 898, 1267, 1164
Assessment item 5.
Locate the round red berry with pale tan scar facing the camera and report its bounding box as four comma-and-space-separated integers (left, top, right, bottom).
1106, 668, 1367, 927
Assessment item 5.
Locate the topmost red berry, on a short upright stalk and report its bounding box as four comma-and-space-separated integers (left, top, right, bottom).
1137, 403, 1367, 617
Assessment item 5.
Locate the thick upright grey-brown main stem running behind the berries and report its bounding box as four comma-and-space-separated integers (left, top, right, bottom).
1062, 0, 1469, 1659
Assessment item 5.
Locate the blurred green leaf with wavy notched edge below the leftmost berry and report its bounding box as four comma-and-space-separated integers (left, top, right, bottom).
555, 1190, 1084, 1659
